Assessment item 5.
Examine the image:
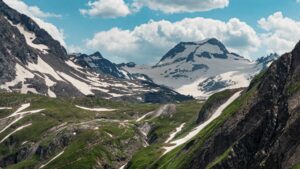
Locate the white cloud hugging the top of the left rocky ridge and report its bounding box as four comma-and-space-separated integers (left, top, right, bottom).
3, 0, 66, 47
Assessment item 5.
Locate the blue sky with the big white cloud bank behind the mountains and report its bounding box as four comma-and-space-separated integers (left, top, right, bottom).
3, 0, 300, 64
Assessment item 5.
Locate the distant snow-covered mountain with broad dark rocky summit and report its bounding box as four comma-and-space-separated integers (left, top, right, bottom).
123, 38, 276, 98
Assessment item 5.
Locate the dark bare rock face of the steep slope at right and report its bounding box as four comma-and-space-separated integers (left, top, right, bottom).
187, 43, 300, 168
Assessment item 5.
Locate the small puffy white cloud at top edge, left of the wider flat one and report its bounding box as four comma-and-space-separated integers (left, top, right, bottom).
80, 0, 131, 18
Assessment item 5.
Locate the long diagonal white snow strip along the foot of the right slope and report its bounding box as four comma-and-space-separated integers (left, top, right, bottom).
164, 91, 242, 154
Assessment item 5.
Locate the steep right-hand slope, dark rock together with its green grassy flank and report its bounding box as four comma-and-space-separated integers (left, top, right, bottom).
127, 42, 300, 169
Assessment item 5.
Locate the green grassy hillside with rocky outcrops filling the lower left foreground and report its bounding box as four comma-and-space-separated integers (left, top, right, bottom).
0, 93, 202, 169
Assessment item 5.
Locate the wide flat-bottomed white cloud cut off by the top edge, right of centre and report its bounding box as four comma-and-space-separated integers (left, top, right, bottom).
134, 0, 229, 13
